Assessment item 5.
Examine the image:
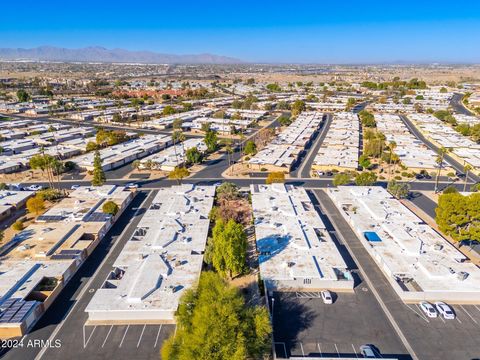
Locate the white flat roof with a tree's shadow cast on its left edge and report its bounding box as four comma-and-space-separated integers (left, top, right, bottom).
251, 184, 353, 291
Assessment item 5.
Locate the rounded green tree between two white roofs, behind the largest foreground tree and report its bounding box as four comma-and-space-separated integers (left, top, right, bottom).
211, 219, 247, 278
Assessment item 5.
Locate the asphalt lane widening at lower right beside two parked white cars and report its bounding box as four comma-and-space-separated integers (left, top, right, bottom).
315, 190, 480, 360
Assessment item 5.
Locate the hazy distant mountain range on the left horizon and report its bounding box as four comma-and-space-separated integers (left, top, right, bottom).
0, 46, 243, 64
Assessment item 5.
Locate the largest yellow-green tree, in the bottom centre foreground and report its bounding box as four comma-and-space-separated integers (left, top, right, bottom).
161, 271, 272, 360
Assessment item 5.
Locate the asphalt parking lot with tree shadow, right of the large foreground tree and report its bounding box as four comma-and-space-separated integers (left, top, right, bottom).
273, 282, 410, 359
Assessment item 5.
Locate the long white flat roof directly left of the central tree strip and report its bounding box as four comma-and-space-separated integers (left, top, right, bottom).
86, 184, 215, 320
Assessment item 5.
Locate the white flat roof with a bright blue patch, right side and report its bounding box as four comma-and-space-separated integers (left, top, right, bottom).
327, 186, 480, 303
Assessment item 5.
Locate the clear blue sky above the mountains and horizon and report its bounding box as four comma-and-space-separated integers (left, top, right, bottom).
0, 0, 480, 63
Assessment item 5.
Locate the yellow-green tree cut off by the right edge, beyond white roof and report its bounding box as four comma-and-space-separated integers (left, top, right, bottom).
435, 192, 480, 241
